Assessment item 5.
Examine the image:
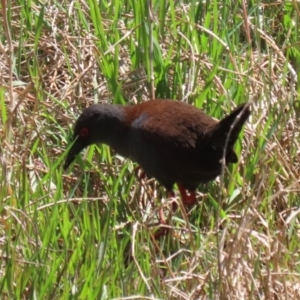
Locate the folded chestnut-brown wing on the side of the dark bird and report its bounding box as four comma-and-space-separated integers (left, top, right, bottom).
126, 100, 213, 172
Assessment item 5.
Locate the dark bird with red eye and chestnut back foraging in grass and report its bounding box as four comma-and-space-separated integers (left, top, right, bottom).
64, 100, 250, 205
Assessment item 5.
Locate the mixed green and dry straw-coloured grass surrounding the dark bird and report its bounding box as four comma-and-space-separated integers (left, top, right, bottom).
0, 0, 300, 299
